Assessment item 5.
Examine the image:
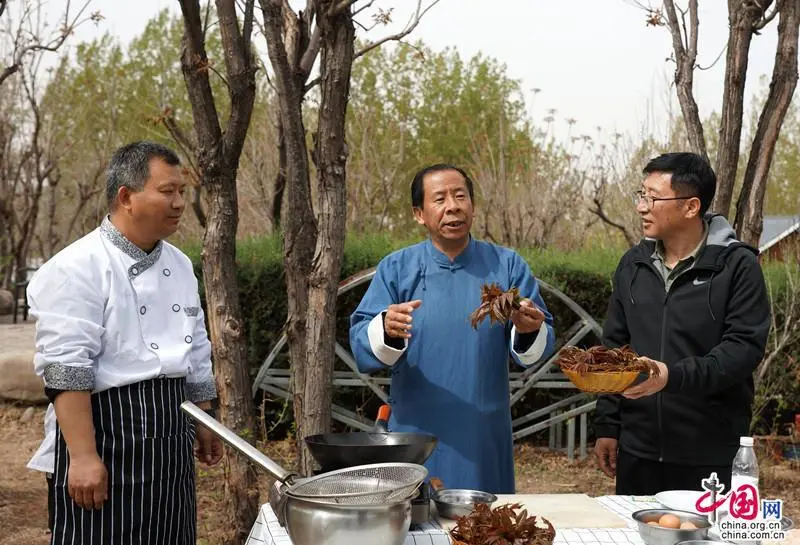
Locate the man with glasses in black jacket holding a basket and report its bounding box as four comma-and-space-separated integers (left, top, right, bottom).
595, 153, 770, 495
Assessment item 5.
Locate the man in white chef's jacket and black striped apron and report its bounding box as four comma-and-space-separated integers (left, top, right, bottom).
27, 142, 222, 545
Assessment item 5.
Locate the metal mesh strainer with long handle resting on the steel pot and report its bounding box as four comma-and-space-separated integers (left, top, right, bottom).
181, 401, 428, 505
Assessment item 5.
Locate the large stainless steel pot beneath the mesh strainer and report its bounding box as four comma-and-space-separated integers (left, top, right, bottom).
283, 492, 411, 545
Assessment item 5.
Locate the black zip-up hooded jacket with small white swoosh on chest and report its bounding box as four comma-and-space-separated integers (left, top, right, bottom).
595, 216, 770, 466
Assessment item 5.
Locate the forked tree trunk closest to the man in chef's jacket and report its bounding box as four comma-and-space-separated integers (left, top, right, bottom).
181, 0, 258, 545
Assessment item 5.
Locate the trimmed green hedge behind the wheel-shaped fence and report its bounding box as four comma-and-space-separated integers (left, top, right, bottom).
184, 236, 800, 435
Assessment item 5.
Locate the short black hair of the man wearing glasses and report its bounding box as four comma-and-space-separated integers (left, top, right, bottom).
642, 152, 717, 217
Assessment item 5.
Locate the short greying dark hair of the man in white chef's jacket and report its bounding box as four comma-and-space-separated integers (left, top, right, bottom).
106, 140, 181, 210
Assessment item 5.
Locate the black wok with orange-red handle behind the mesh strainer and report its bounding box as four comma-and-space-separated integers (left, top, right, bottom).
305, 405, 437, 471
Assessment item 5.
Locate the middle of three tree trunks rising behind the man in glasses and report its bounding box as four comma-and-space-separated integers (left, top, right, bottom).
711, 0, 772, 217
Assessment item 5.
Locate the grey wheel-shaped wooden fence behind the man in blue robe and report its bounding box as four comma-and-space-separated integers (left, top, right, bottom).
252, 267, 602, 459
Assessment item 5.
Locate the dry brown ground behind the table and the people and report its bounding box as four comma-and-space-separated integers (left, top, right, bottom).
0, 404, 800, 545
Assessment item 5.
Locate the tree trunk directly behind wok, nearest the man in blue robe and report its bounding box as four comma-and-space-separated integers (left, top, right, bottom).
295, 1, 355, 465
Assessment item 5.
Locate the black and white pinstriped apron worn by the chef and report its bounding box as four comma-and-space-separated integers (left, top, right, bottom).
51, 379, 196, 545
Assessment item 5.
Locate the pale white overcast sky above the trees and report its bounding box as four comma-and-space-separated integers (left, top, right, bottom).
48, 0, 777, 143
